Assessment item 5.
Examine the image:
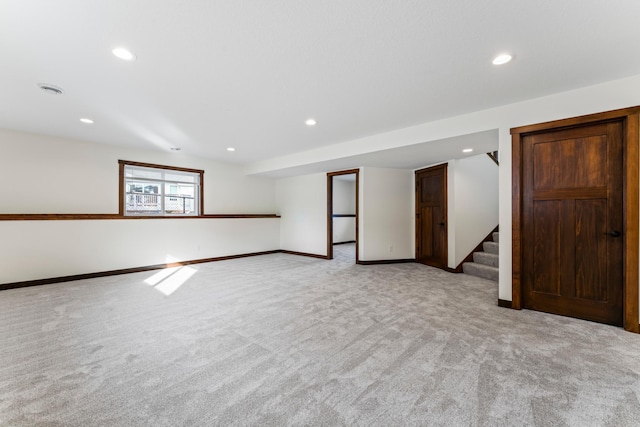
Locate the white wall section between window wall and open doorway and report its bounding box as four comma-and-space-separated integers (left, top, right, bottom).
276, 173, 327, 255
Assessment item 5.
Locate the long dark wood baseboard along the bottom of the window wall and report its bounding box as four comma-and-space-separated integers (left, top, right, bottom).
0, 250, 282, 291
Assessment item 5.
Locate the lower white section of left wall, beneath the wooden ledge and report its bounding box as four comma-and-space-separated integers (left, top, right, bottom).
0, 218, 280, 283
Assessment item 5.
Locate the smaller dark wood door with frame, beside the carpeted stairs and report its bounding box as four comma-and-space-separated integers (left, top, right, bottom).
416, 164, 447, 268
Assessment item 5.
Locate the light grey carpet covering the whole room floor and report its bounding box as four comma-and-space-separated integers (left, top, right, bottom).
0, 245, 640, 427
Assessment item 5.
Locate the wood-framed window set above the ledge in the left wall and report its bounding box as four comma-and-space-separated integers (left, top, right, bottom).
118, 160, 204, 216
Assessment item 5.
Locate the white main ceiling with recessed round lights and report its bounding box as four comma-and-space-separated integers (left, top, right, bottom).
0, 0, 640, 173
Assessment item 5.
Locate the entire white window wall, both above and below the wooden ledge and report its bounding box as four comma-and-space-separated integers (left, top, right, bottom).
0, 130, 280, 283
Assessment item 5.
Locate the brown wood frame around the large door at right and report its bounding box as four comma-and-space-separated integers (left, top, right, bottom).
511, 106, 640, 333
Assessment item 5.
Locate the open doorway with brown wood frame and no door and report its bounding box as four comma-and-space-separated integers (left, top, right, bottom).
327, 169, 360, 263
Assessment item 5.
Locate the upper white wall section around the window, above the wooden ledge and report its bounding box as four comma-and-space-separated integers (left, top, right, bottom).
0, 129, 276, 214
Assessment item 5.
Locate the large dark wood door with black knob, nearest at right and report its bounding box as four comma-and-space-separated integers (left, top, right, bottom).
522, 122, 624, 325
